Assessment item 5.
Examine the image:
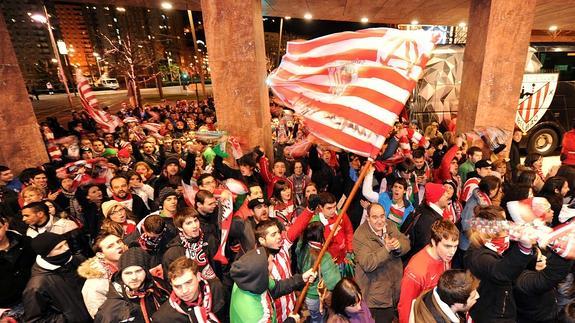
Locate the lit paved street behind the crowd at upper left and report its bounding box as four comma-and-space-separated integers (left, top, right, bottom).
32, 84, 212, 122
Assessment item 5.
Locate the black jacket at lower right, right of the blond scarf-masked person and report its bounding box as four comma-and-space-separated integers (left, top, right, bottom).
513, 252, 573, 323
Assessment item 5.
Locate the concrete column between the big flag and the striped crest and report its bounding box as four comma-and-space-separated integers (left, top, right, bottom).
457, 0, 536, 143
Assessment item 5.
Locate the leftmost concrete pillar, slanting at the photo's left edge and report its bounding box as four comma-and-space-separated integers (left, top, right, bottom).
0, 14, 49, 172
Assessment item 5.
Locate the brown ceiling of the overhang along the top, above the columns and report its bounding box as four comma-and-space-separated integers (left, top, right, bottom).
63, 0, 575, 30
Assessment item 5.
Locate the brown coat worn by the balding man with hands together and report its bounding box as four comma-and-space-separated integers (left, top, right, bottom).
353, 220, 410, 308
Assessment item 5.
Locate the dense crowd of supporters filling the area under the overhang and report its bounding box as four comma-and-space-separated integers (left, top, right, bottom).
0, 99, 575, 323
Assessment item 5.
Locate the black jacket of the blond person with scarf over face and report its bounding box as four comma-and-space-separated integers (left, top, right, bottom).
464, 243, 534, 323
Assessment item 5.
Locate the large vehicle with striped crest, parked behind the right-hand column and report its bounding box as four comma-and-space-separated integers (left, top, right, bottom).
408, 44, 575, 156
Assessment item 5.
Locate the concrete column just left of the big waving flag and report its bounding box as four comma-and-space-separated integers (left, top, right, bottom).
202, 0, 273, 158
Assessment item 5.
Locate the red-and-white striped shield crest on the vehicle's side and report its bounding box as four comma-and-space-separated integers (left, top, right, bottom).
515, 74, 559, 132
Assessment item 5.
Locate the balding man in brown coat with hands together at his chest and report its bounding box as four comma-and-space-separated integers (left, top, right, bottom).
353, 203, 410, 322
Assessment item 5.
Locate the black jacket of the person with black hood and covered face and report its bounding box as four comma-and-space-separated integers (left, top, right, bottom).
22, 257, 92, 323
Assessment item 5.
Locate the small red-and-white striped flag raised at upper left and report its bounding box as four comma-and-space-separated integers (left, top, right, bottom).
76, 69, 122, 133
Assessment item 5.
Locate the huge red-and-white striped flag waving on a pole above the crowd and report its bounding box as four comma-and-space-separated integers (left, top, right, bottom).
267, 28, 439, 157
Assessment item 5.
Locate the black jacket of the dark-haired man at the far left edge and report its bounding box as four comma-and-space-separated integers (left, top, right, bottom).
0, 231, 36, 308
